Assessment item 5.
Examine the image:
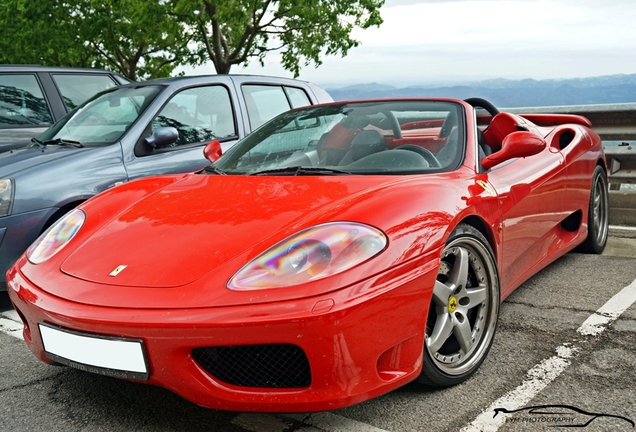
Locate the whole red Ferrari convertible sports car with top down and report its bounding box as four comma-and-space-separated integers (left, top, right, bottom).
7, 99, 608, 412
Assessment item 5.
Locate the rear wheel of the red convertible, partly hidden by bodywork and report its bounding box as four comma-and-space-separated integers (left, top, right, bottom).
579, 165, 609, 254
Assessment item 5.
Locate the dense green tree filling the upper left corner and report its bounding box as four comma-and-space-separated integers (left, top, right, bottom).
0, 0, 198, 80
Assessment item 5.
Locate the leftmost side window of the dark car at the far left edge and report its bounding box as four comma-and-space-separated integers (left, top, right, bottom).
0, 75, 53, 127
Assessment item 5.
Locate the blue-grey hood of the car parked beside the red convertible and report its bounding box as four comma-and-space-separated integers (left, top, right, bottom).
0, 146, 84, 178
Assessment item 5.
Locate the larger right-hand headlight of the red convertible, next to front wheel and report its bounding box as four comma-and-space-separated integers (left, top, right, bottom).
227, 222, 388, 291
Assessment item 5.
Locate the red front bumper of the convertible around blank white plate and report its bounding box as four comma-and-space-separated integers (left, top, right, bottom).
7, 260, 438, 412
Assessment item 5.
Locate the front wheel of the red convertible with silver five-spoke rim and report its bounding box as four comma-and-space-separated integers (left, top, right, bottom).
416, 224, 500, 387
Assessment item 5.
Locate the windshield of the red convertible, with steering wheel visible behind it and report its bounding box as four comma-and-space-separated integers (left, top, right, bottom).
216, 100, 465, 175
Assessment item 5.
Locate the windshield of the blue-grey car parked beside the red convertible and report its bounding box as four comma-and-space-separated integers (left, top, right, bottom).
38, 86, 162, 145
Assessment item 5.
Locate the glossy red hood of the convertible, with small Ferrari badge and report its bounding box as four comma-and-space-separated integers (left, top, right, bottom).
61, 175, 398, 288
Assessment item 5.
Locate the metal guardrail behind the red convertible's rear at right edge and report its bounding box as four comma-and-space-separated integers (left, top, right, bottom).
506, 103, 636, 226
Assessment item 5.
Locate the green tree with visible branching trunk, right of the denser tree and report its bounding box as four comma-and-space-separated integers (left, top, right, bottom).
172, 0, 384, 76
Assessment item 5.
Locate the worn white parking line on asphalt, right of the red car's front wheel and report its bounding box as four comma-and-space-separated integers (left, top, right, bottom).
461, 280, 636, 432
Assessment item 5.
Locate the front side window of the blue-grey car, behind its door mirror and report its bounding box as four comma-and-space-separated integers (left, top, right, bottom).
152, 85, 237, 148
